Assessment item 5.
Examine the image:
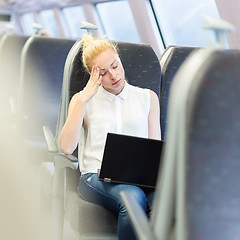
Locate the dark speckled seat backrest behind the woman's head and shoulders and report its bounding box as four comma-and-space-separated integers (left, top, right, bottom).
56, 40, 161, 155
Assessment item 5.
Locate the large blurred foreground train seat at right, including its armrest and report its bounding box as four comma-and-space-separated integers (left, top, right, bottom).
122, 49, 240, 240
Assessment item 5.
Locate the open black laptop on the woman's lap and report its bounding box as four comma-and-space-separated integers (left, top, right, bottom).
99, 133, 163, 188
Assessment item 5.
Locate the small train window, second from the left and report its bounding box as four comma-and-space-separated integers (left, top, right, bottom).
38, 9, 60, 37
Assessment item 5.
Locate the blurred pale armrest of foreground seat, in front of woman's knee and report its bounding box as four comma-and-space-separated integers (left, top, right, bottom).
120, 191, 156, 240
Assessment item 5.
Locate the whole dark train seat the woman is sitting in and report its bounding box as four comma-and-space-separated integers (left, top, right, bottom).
44, 40, 161, 239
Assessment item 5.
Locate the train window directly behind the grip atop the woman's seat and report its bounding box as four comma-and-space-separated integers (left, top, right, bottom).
62, 6, 87, 38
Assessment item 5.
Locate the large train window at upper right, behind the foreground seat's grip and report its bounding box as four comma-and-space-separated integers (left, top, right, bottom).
151, 0, 219, 47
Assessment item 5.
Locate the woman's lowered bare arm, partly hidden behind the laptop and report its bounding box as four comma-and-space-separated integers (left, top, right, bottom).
148, 90, 161, 140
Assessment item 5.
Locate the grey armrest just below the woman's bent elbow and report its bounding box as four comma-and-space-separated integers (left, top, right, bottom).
54, 153, 78, 170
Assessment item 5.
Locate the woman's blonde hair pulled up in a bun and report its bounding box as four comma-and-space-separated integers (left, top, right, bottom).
81, 34, 118, 73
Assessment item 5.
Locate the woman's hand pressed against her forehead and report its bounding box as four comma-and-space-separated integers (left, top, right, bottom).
81, 65, 102, 102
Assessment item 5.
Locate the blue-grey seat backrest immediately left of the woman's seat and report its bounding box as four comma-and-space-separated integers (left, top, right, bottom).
18, 36, 75, 136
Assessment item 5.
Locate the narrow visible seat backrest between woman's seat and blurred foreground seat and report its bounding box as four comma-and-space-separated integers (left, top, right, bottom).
160, 46, 196, 140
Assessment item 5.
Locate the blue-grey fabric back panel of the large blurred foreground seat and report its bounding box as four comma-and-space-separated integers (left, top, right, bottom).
185, 50, 240, 240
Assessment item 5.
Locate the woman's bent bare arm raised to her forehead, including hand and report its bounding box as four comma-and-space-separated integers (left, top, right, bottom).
59, 66, 102, 154
